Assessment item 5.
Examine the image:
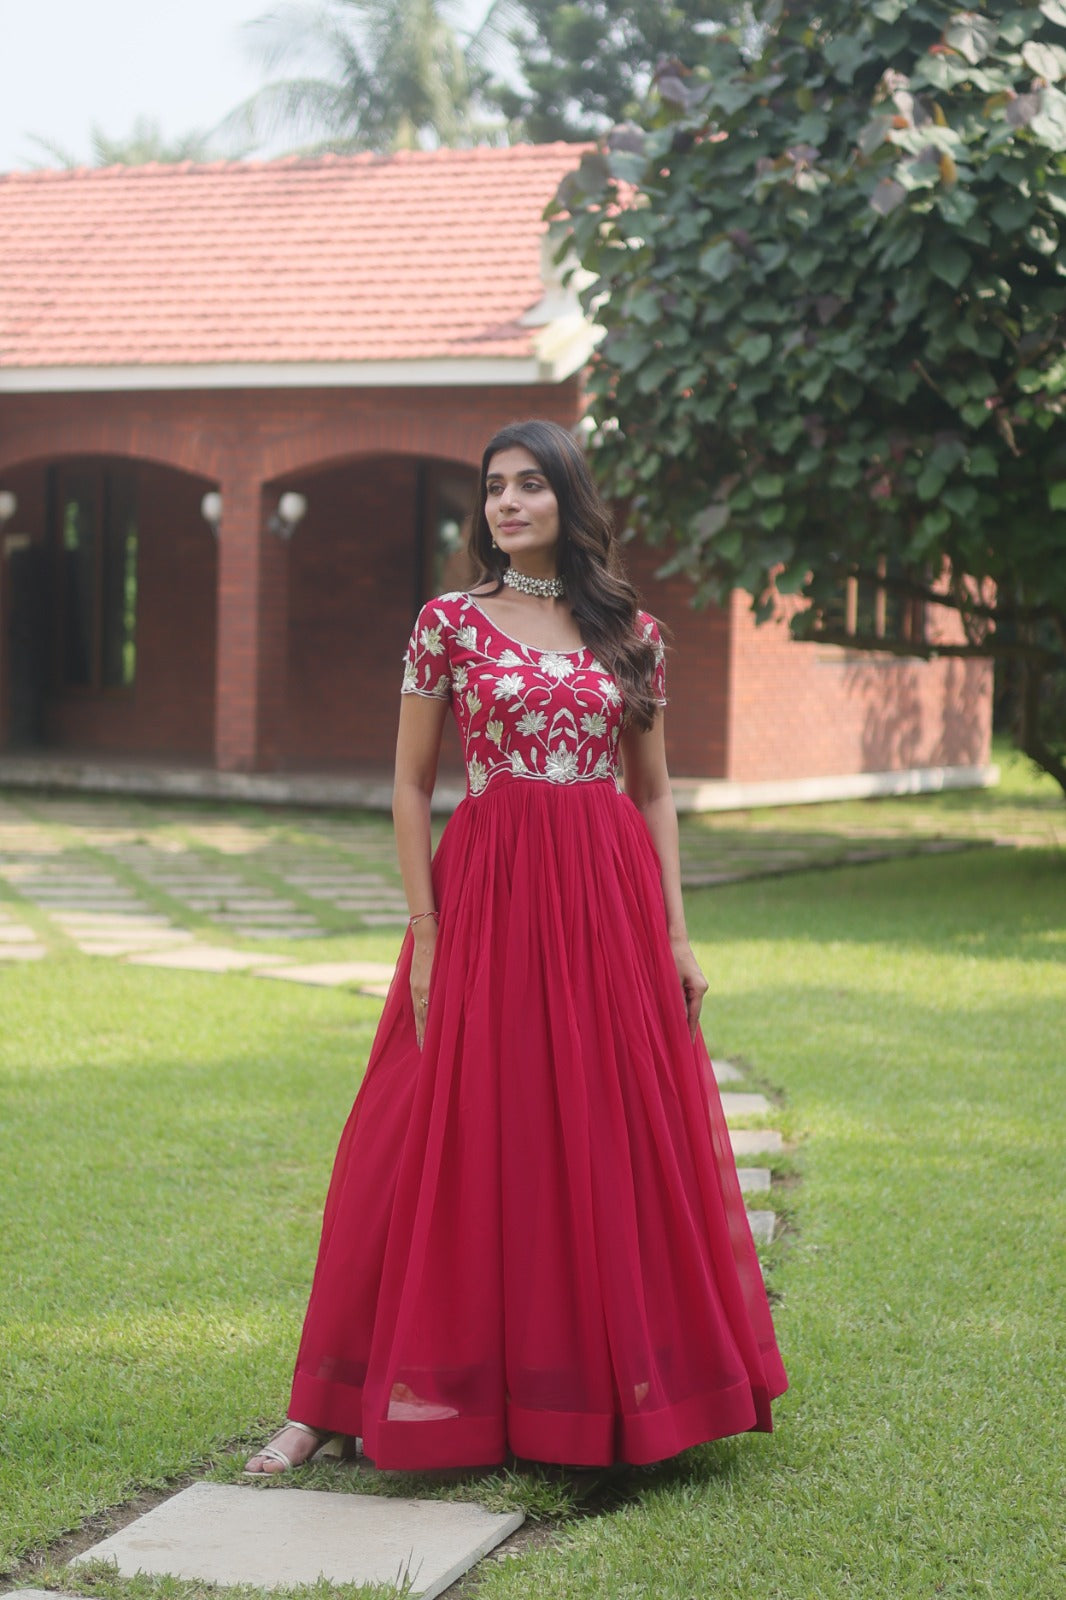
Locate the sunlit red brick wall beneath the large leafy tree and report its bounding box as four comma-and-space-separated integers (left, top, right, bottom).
727, 594, 992, 782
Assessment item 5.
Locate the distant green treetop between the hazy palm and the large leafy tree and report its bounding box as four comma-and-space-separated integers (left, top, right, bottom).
493, 0, 735, 141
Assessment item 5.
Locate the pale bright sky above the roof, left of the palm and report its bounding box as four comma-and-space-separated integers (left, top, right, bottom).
0, 0, 487, 171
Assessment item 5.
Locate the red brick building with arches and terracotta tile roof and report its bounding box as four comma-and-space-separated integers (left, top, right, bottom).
0, 144, 991, 803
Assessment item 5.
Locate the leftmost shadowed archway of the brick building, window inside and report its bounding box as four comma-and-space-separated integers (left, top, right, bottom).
0, 454, 218, 760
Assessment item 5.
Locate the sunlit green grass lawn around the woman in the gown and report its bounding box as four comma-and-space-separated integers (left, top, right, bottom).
0, 774, 1066, 1600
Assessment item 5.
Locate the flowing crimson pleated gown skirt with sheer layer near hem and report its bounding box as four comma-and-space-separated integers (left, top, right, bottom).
288, 774, 786, 1469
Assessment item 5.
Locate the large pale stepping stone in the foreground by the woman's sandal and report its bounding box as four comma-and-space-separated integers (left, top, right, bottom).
72, 1483, 523, 1600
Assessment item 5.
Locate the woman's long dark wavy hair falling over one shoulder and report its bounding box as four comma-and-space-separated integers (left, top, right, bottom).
469, 418, 656, 728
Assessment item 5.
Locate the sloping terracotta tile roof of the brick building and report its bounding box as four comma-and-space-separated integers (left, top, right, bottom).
0, 144, 581, 368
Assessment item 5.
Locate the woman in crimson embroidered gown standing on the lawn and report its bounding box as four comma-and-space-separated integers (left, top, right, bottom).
246, 421, 786, 1475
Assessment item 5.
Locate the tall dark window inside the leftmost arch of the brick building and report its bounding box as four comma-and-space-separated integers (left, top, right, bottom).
53, 462, 138, 688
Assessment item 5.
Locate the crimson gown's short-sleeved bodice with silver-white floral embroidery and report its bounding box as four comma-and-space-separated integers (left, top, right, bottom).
403, 594, 666, 795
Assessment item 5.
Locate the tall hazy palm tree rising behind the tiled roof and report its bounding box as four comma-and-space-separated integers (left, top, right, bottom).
226, 0, 517, 152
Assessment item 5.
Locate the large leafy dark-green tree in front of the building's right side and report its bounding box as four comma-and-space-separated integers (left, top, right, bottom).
555, 0, 1066, 790
